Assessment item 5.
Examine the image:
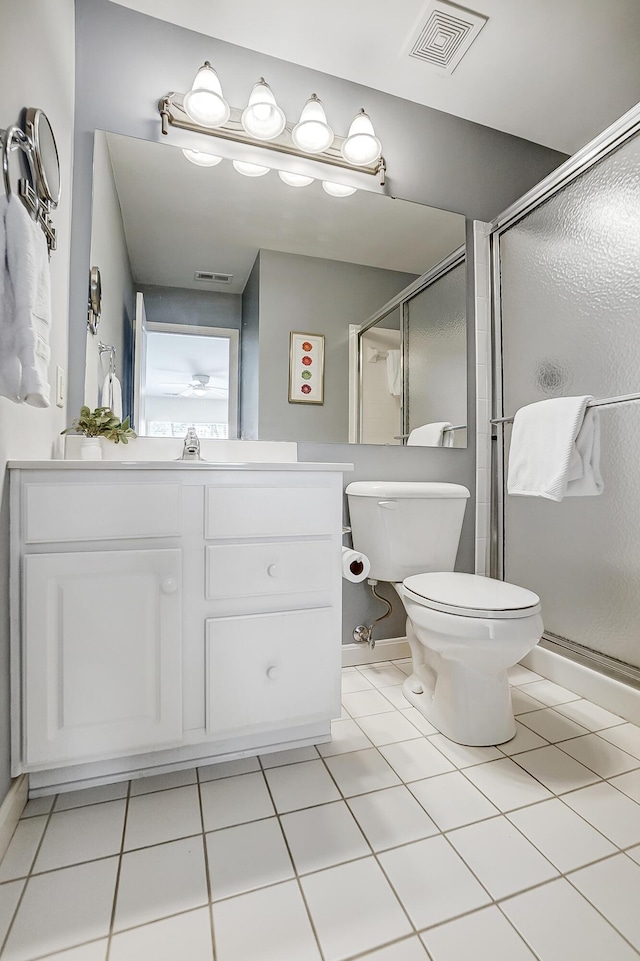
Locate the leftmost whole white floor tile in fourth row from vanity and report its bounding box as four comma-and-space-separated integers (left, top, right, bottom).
301, 858, 411, 961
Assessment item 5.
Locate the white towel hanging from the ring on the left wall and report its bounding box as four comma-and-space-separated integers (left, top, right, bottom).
5, 194, 51, 407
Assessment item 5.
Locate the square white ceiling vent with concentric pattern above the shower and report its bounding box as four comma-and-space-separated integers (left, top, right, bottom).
409, 0, 488, 74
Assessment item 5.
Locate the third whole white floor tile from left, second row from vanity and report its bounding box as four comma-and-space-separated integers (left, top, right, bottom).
200, 773, 275, 831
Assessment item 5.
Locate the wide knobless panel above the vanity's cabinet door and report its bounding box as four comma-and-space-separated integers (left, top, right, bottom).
22, 483, 181, 544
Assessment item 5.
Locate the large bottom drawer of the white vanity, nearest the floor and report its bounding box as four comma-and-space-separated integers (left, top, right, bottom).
206, 608, 340, 734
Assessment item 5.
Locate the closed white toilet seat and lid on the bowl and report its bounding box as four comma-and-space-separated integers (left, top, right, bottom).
402, 571, 541, 618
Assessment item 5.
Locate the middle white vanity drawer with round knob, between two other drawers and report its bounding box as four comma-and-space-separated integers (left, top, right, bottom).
205, 538, 338, 603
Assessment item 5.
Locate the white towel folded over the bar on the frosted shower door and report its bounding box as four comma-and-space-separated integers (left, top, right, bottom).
507, 395, 604, 501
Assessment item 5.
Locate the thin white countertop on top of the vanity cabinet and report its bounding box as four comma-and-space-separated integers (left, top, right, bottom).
7, 460, 353, 471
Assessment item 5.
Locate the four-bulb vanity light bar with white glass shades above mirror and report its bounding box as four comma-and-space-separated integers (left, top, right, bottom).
158, 61, 386, 186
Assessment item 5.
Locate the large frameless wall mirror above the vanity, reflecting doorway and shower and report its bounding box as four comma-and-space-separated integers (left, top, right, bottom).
85, 131, 467, 446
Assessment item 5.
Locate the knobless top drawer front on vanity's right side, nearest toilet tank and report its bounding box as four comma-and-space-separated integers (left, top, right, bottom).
204, 483, 342, 539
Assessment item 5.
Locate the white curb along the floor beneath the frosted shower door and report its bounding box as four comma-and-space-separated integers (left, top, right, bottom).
522, 646, 640, 724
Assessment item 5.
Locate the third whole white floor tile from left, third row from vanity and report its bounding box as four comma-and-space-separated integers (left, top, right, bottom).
206, 818, 293, 900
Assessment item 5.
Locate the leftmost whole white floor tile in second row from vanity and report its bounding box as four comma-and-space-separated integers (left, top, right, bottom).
33, 800, 127, 873
